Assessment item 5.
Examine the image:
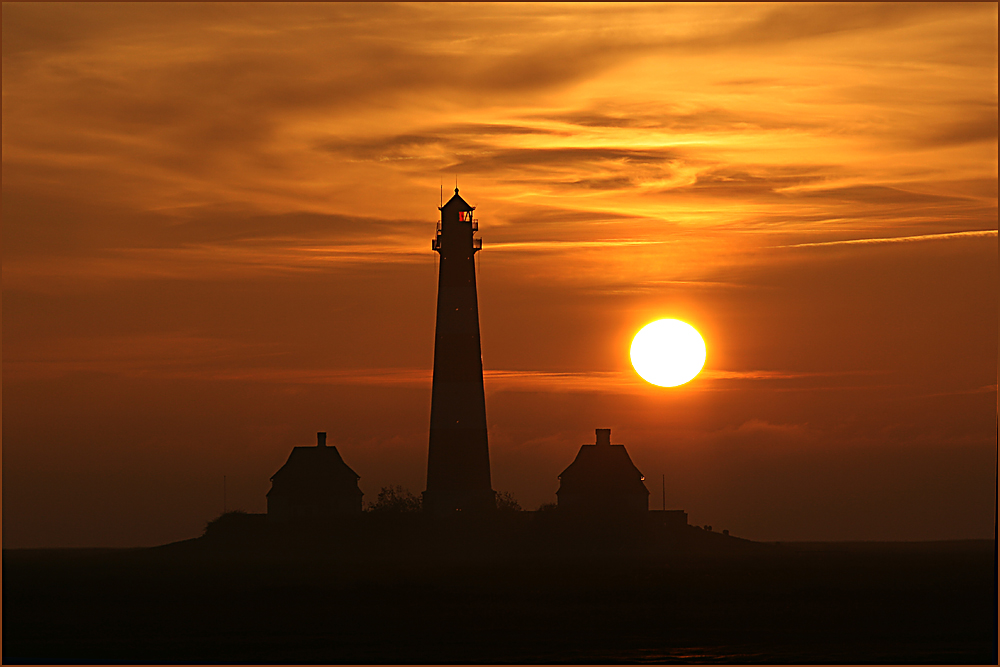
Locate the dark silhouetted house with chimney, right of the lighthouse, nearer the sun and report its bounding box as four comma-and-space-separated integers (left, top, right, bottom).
556, 428, 649, 516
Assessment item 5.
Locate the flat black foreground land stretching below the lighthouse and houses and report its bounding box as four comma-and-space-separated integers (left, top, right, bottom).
3, 529, 997, 664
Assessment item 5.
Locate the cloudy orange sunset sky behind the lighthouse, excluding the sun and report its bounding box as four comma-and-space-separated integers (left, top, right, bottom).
2, 3, 998, 547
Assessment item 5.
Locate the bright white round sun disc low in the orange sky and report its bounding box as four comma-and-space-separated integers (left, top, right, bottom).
630, 320, 705, 387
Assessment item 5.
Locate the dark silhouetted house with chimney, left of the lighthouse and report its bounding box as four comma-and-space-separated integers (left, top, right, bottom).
267, 433, 364, 520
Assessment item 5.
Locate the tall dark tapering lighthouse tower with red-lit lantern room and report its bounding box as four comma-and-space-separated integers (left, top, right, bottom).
423, 188, 496, 514
